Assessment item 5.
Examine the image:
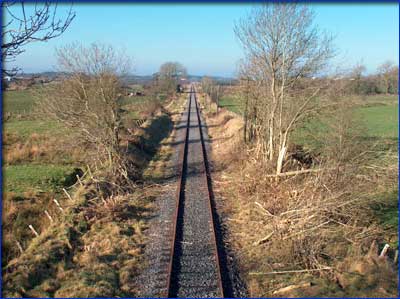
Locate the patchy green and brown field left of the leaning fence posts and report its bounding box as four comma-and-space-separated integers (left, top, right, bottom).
2, 89, 83, 272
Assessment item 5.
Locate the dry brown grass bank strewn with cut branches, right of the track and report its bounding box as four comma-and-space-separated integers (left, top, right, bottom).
202, 95, 397, 297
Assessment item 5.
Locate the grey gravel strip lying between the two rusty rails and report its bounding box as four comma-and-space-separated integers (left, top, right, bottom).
170, 93, 221, 297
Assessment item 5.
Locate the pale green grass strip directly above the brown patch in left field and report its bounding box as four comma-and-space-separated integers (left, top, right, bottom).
3, 120, 66, 138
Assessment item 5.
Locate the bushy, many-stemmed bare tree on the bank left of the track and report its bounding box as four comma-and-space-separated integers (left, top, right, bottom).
40, 44, 129, 183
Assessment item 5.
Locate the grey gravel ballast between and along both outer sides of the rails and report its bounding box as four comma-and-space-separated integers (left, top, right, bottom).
138, 93, 245, 297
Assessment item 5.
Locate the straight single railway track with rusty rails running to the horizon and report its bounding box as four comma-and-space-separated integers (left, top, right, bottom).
165, 87, 224, 297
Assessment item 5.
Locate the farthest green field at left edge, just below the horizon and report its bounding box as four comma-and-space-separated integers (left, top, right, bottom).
3, 89, 35, 115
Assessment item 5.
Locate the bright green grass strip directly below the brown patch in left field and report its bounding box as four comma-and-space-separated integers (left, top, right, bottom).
3, 164, 74, 194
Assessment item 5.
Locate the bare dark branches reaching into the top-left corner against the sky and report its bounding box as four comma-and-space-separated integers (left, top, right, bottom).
1, 1, 75, 76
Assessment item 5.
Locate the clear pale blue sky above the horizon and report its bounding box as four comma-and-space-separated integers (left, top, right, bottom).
4, 4, 399, 76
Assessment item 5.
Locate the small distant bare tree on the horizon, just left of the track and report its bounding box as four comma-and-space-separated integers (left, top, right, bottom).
156, 62, 186, 94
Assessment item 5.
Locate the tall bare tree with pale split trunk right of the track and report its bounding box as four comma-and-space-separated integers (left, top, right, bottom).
235, 3, 333, 174
